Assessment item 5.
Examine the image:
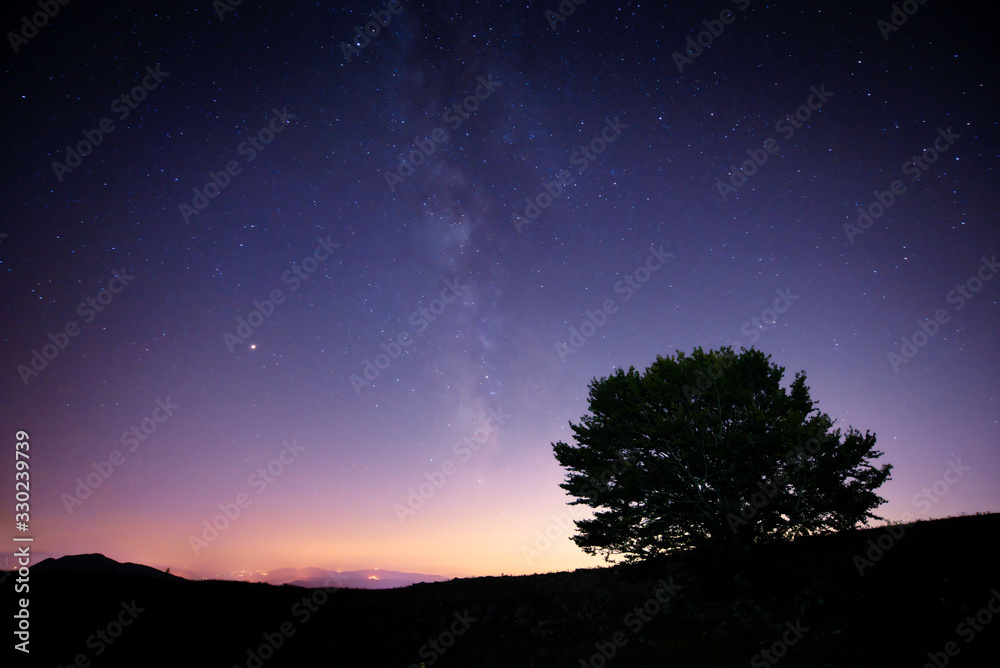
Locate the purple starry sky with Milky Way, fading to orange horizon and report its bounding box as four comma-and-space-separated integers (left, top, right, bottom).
0, 0, 1000, 575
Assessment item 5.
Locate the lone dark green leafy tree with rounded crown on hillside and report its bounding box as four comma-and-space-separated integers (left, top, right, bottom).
552, 347, 892, 562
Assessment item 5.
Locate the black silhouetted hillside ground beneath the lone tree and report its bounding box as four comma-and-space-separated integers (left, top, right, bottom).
3, 514, 1000, 668
